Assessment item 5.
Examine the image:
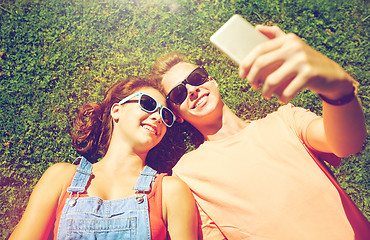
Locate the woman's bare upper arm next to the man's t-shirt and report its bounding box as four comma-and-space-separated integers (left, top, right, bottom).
162, 176, 198, 240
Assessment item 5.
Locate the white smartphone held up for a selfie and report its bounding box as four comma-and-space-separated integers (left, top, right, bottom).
210, 14, 269, 65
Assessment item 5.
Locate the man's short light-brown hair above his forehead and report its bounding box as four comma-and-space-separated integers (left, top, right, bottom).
150, 51, 189, 84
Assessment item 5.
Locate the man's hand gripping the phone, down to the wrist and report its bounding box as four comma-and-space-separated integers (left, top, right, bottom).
239, 25, 355, 103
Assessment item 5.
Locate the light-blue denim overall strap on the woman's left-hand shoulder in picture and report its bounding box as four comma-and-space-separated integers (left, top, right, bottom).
67, 156, 92, 193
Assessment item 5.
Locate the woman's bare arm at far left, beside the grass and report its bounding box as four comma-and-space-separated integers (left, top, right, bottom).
9, 163, 75, 240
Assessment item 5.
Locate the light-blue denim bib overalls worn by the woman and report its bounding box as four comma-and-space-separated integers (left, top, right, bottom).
57, 157, 157, 240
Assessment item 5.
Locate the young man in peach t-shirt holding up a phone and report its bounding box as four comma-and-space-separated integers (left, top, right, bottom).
152, 26, 370, 240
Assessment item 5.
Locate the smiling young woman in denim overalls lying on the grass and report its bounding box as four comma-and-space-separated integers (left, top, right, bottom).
10, 78, 197, 239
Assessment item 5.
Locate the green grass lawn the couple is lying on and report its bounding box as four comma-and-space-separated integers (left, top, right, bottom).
0, 0, 370, 239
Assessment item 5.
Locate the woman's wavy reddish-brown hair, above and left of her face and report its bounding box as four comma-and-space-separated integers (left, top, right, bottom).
70, 77, 163, 162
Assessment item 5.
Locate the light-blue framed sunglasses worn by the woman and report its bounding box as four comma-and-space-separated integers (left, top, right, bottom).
118, 92, 176, 127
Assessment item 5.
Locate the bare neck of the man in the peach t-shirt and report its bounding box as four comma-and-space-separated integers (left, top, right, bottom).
193, 104, 249, 141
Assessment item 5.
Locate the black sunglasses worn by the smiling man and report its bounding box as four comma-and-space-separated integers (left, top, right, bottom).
166, 67, 208, 105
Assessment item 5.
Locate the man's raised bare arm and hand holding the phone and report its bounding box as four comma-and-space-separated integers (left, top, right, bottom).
239, 26, 366, 157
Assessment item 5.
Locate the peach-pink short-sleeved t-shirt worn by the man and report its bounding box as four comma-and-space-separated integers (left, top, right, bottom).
173, 104, 370, 240
